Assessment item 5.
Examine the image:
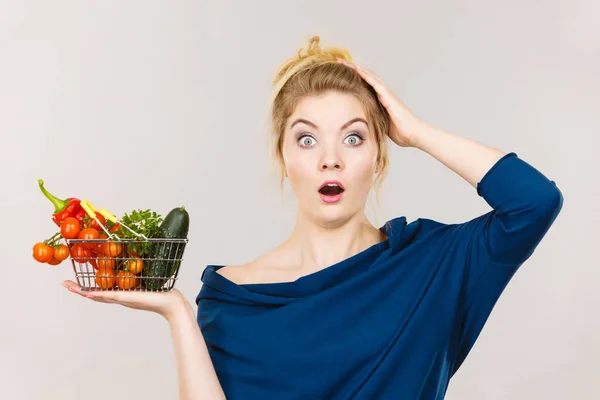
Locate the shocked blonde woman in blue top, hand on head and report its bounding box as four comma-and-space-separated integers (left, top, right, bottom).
65, 36, 563, 400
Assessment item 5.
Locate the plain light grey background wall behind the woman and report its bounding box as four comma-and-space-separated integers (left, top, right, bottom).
0, 0, 600, 400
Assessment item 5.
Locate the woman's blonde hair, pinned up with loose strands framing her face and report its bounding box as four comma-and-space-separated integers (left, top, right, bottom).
269, 36, 390, 206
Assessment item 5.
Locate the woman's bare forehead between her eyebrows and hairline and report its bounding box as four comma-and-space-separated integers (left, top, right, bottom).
287, 92, 366, 130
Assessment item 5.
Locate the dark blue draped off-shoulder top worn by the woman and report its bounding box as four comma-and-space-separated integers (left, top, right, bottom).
196, 153, 563, 400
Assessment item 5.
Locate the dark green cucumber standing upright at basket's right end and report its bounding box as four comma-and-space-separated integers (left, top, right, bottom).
142, 206, 190, 290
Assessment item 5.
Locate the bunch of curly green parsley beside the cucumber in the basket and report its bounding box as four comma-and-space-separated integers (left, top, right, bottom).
117, 209, 163, 256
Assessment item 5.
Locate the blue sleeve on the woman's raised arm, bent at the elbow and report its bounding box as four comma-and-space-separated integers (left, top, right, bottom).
452, 153, 563, 373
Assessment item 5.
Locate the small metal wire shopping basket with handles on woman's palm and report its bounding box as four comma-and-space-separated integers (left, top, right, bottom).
66, 200, 188, 292
